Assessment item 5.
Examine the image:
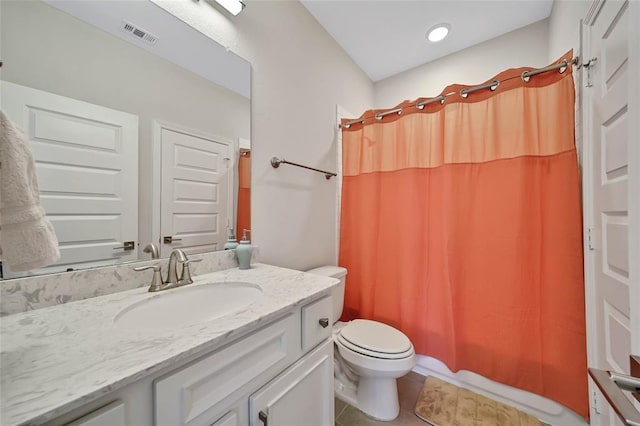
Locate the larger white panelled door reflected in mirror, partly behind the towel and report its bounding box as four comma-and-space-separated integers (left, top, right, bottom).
1, 81, 138, 278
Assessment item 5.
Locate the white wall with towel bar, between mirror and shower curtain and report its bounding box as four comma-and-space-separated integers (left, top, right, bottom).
152, 0, 373, 269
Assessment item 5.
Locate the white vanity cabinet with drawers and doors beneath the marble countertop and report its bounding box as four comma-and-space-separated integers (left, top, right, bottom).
50, 296, 334, 426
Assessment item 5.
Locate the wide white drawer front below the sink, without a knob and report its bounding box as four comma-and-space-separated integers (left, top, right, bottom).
154, 314, 300, 426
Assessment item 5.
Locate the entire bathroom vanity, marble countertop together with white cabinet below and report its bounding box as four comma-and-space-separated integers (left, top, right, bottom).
1, 264, 338, 426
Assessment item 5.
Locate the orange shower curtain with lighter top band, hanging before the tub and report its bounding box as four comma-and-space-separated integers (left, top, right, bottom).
340, 52, 588, 417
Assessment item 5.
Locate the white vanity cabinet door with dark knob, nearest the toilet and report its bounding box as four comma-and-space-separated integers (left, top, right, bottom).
249, 340, 334, 426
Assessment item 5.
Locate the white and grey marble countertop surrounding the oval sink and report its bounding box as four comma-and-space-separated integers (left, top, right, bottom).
0, 264, 338, 426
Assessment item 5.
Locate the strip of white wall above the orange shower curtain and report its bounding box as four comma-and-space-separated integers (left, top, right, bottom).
375, 19, 549, 108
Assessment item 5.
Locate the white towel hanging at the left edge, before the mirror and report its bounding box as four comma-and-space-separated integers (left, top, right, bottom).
0, 111, 60, 272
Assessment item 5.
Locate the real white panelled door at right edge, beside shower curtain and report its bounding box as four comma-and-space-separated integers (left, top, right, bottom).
583, 1, 640, 426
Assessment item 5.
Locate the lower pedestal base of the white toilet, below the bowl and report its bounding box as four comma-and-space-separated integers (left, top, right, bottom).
334, 377, 400, 422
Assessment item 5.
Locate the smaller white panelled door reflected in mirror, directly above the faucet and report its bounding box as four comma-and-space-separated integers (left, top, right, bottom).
160, 126, 233, 257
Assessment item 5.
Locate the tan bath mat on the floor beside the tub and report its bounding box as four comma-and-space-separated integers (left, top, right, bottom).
415, 376, 544, 426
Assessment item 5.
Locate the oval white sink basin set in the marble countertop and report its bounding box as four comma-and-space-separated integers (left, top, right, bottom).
115, 282, 262, 329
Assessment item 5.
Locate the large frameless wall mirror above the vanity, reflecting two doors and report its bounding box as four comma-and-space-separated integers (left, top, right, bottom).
0, 0, 251, 279
